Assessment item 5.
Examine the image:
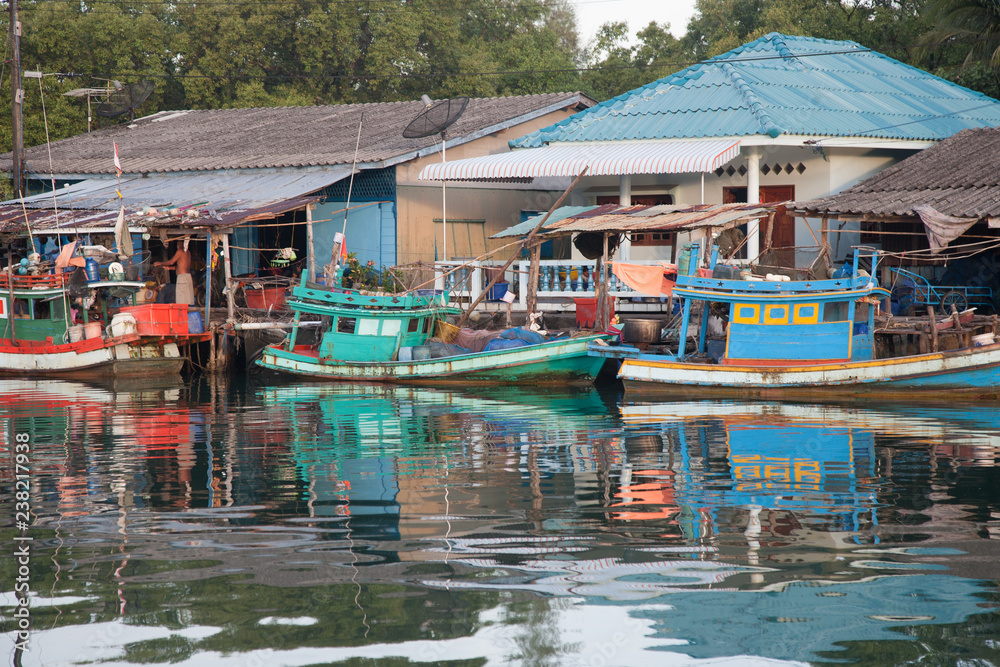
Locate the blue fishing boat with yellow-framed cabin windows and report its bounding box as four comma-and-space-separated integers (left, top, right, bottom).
590, 249, 1000, 396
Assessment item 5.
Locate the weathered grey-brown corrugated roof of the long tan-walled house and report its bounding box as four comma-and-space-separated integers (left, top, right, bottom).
0, 92, 594, 175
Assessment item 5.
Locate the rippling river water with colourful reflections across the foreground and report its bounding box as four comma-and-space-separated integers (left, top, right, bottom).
0, 379, 1000, 667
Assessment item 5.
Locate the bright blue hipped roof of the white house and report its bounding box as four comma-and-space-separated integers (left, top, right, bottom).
510, 33, 1000, 148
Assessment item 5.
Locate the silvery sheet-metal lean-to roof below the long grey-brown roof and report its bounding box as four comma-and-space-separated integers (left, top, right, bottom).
0, 167, 351, 233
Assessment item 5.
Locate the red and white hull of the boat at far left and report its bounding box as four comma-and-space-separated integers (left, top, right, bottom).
0, 335, 186, 379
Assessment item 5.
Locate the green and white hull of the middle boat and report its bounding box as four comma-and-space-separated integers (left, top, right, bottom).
257, 335, 606, 385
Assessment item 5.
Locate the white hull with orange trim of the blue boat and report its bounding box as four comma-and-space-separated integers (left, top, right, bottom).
618, 344, 1000, 397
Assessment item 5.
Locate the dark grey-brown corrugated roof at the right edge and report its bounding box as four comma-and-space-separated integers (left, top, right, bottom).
793, 128, 1000, 218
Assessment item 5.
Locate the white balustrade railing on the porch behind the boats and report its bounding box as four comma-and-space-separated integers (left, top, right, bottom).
434, 259, 672, 310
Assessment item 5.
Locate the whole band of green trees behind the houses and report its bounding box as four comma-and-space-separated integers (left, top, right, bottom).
0, 0, 1000, 171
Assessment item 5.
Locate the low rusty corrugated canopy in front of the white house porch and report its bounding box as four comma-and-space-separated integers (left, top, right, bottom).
493, 204, 774, 238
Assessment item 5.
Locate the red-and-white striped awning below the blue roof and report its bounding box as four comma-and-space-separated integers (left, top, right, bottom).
418, 139, 740, 181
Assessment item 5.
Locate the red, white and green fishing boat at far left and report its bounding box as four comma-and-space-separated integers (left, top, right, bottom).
0, 269, 208, 379
